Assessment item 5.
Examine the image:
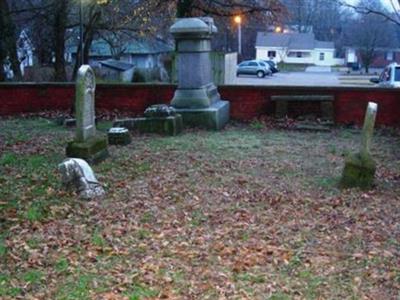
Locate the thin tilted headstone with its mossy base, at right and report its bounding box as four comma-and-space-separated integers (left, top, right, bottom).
341, 102, 378, 189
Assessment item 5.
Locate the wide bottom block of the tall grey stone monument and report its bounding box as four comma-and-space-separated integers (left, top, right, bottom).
175, 101, 230, 130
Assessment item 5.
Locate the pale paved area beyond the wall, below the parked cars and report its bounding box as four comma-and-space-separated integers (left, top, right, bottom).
235, 72, 340, 86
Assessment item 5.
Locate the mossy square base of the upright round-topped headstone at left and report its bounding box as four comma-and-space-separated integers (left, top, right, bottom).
66, 136, 109, 163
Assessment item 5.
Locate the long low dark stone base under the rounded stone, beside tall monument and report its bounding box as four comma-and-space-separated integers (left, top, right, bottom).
113, 114, 183, 136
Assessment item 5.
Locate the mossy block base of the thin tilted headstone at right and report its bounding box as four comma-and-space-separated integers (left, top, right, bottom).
340, 153, 376, 189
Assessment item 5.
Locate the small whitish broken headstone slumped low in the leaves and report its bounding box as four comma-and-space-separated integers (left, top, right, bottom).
58, 158, 105, 199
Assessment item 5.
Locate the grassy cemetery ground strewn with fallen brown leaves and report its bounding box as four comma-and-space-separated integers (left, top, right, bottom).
0, 118, 400, 300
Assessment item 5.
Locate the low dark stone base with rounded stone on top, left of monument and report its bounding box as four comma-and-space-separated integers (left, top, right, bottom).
113, 104, 183, 136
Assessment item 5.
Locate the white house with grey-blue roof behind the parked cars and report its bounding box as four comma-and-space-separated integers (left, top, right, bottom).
256, 32, 344, 66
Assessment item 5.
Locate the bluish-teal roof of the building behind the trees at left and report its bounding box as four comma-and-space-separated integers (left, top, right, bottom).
69, 39, 173, 56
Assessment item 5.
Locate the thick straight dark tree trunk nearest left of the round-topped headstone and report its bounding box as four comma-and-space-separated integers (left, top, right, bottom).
53, 0, 68, 81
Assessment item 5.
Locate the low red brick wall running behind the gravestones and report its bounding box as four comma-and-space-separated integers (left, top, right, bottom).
0, 84, 400, 126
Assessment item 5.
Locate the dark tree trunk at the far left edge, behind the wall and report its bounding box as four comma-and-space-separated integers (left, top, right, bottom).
0, 0, 22, 81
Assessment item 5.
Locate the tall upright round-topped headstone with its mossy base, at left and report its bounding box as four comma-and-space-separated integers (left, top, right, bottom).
66, 65, 108, 163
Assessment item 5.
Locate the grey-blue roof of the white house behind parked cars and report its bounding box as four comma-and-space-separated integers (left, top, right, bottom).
256, 32, 335, 50
